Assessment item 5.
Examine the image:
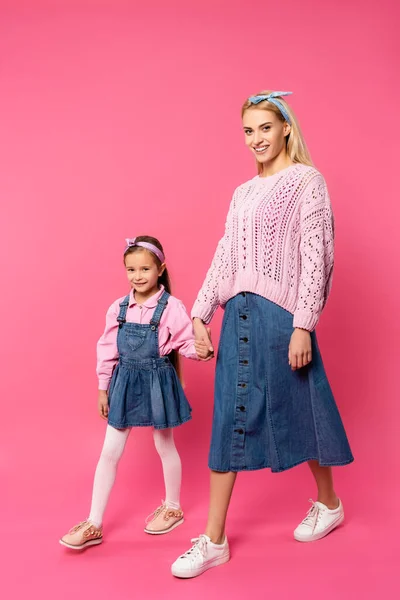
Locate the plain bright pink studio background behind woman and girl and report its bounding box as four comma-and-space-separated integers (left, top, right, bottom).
0, 0, 400, 600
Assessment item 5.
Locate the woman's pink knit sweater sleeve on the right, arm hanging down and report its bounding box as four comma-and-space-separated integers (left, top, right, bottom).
293, 174, 334, 331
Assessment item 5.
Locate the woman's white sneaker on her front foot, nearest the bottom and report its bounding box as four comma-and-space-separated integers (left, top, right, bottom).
171, 534, 230, 578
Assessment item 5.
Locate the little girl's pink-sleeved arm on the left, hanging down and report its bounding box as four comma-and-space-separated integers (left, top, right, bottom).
96, 300, 120, 390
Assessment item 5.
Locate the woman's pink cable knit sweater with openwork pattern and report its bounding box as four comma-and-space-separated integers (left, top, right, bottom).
192, 164, 334, 331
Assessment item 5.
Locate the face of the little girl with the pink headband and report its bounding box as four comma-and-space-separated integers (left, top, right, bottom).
125, 248, 165, 294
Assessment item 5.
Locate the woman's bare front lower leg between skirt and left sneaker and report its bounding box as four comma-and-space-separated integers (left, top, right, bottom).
205, 471, 237, 544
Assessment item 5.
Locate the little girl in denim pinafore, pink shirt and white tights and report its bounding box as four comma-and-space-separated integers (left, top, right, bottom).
60, 236, 211, 550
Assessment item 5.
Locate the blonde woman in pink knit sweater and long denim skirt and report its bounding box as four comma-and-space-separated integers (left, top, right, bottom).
172, 92, 353, 577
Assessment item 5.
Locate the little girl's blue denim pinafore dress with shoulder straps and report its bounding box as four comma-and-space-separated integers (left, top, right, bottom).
108, 292, 191, 429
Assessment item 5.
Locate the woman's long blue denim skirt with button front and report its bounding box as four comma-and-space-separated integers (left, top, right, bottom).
209, 292, 354, 472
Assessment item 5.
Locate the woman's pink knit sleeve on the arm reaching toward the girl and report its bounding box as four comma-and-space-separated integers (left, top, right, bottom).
191, 188, 238, 324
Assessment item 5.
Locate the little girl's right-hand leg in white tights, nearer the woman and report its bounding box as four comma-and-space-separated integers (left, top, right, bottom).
154, 429, 182, 509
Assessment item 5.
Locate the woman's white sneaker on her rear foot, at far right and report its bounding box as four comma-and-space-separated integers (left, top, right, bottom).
294, 500, 344, 542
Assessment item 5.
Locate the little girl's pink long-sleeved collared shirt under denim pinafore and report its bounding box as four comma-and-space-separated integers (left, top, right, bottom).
96, 286, 197, 390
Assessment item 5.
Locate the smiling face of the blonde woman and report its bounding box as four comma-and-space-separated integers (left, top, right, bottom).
243, 108, 290, 165
